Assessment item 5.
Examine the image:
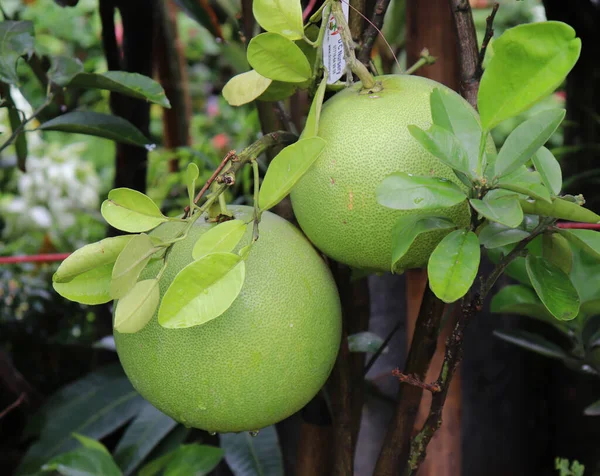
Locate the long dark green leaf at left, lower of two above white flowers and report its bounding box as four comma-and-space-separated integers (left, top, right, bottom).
38, 111, 152, 147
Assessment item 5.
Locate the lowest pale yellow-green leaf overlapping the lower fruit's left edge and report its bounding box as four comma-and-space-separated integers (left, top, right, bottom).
114, 279, 160, 334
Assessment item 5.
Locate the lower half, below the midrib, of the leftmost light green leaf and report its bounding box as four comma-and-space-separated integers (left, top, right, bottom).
52, 263, 114, 305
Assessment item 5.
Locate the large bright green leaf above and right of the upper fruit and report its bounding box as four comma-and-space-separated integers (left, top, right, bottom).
477, 21, 581, 130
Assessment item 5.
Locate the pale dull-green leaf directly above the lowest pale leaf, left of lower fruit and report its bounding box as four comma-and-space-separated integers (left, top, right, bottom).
110, 233, 158, 299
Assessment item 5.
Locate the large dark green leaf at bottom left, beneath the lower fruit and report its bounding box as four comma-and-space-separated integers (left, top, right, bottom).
15, 364, 145, 476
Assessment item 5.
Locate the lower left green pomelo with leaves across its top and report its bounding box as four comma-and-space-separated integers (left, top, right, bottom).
114, 206, 341, 433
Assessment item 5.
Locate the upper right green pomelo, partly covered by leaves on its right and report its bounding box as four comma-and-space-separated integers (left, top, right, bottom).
291, 75, 476, 272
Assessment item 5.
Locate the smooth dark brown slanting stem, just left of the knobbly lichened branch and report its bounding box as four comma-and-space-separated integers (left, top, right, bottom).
374, 286, 444, 476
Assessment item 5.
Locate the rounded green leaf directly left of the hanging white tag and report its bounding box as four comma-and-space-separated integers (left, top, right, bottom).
247, 33, 312, 83
